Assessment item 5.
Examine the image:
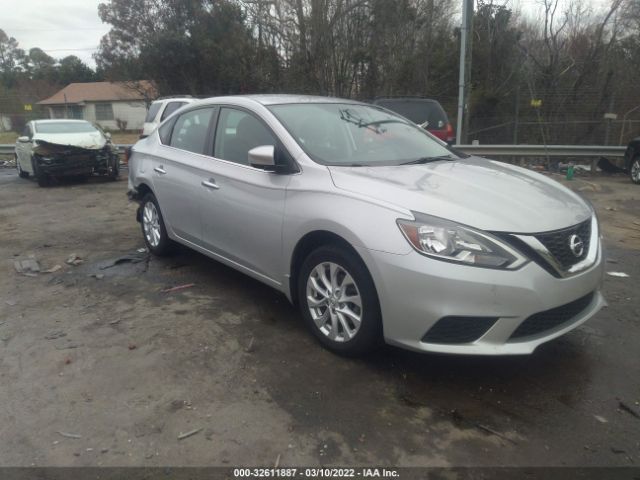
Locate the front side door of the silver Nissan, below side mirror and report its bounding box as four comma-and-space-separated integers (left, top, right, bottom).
201, 106, 290, 285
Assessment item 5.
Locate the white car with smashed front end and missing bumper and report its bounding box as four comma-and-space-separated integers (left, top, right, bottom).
15, 119, 119, 187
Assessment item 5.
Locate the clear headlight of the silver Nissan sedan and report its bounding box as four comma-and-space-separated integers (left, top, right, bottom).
398, 213, 527, 270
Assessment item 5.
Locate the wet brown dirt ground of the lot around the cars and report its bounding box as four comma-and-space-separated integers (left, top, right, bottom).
0, 169, 640, 466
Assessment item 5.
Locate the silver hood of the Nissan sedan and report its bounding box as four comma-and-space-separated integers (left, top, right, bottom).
328, 157, 592, 233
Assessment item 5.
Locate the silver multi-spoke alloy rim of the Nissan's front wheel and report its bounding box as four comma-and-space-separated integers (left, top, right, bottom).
306, 262, 363, 342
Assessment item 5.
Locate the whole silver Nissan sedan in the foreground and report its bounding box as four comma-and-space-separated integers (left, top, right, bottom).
129, 95, 605, 355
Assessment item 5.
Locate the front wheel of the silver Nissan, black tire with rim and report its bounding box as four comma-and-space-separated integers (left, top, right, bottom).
297, 245, 382, 356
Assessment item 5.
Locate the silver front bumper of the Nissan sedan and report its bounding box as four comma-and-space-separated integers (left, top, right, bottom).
357, 242, 606, 355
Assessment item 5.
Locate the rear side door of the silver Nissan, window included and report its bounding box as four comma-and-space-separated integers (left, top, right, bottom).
152, 107, 216, 245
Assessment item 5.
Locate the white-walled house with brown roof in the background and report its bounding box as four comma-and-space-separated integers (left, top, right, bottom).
38, 80, 155, 130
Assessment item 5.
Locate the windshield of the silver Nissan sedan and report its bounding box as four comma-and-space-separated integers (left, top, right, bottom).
270, 103, 456, 166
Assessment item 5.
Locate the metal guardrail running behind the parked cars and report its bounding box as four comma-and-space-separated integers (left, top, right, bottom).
0, 144, 626, 158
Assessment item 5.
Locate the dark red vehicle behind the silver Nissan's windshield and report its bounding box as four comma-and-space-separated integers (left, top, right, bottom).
373, 97, 456, 144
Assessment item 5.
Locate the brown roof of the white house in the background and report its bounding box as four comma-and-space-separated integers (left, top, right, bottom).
38, 80, 156, 105
